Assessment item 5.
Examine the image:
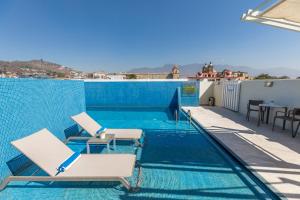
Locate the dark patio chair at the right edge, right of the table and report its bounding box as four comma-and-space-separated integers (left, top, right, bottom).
272, 108, 300, 137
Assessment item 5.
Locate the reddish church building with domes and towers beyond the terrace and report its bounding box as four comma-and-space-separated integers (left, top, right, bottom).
189, 62, 250, 81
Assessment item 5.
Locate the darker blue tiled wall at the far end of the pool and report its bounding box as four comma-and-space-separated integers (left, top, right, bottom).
84, 81, 199, 107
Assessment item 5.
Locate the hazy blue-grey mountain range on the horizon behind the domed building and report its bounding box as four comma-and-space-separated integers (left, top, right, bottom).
128, 63, 300, 78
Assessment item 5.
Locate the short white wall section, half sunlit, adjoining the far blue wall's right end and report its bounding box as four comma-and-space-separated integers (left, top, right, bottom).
199, 80, 214, 105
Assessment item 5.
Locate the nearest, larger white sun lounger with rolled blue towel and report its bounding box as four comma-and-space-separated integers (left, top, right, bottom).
0, 129, 141, 190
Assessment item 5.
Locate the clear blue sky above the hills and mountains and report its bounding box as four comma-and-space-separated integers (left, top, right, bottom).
0, 0, 300, 72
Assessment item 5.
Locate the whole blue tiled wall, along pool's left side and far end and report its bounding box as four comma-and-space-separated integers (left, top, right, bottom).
0, 79, 199, 181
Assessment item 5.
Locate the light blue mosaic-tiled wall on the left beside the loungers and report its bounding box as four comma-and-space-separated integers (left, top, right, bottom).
0, 79, 85, 181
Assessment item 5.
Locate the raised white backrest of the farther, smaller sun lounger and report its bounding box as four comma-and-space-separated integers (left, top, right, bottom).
71, 112, 102, 136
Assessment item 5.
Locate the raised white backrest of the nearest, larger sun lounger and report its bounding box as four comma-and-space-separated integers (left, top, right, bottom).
11, 129, 74, 176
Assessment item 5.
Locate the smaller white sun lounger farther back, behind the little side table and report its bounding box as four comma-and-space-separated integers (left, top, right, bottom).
67, 112, 143, 145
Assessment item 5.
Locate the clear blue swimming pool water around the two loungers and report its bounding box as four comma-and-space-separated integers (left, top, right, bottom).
0, 108, 277, 200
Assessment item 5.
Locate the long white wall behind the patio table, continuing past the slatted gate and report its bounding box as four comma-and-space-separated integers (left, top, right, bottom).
200, 79, 300, 129
